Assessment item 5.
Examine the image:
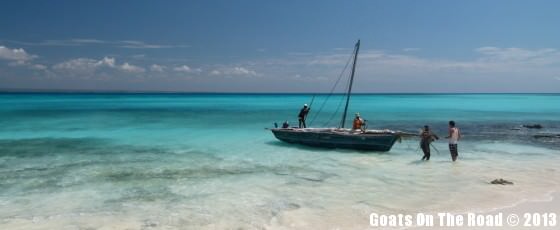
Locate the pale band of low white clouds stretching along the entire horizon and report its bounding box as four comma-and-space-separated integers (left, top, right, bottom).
0, 43, 560, 92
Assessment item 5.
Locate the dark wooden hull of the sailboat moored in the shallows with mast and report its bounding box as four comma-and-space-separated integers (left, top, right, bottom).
271, 128, 400, 152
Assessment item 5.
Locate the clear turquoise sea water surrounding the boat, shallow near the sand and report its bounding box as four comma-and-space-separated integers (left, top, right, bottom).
0, 94, 560, 229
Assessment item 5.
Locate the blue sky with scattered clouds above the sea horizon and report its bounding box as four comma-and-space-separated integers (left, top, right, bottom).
0, 0, 560, 93
